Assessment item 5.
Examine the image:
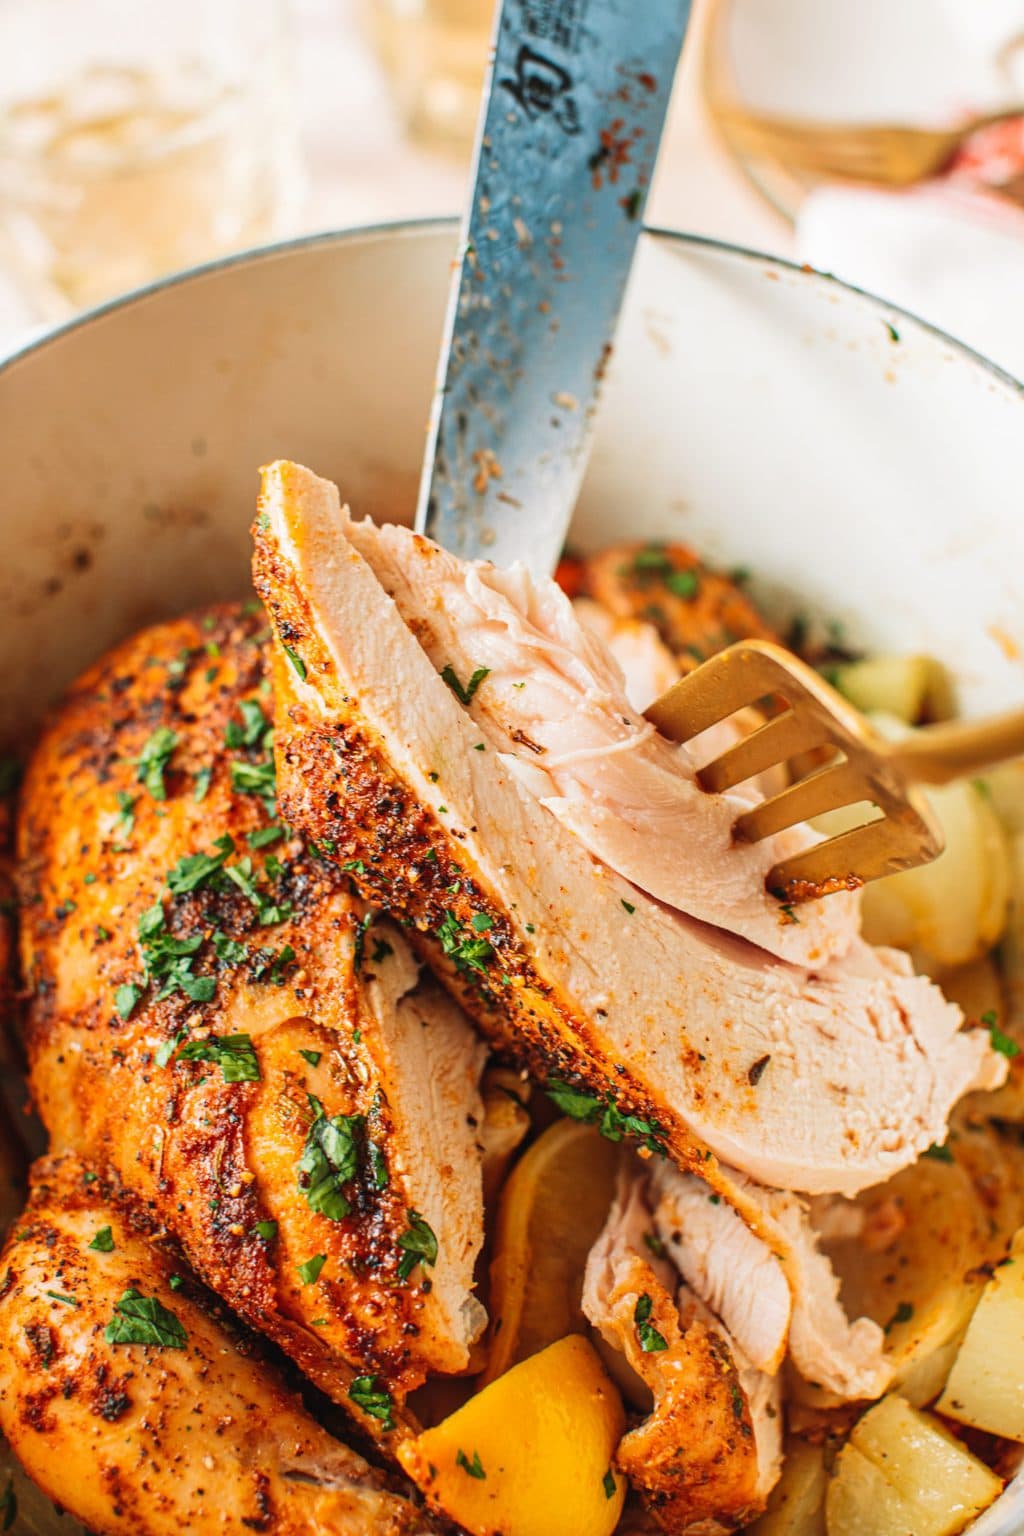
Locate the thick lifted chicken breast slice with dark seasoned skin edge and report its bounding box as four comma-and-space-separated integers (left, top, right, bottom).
255, 464, 1006, 1192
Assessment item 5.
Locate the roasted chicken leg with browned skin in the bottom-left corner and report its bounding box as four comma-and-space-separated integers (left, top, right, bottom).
0, 1157, 433, 1536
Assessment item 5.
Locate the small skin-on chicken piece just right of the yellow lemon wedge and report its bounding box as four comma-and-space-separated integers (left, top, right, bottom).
583, 1175, 781, 1536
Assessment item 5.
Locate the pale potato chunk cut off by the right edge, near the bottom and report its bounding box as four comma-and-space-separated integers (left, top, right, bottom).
938, 1230, 1024, 1441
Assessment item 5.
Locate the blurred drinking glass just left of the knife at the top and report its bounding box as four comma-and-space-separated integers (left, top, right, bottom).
365, 0, 496, 149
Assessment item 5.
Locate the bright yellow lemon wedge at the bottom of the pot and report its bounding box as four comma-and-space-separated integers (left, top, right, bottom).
398, 1335, 626, 1536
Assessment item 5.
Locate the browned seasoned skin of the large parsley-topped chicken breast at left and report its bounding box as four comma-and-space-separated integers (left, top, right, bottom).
20, 607, 463, 1432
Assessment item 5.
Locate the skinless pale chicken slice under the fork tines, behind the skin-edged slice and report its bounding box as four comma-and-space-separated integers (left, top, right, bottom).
337, 506, 860, 965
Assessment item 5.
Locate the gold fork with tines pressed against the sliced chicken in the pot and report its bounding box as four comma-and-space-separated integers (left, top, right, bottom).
645, 641, 1024, 903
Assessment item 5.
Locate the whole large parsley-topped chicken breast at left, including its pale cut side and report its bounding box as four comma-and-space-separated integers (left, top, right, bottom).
20, 608, 485, 1433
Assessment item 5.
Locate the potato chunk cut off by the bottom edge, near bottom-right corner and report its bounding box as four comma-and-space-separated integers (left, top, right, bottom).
826, 1396, 1003, 1536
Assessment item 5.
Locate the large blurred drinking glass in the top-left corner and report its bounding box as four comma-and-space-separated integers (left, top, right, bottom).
0, 0, 298, 318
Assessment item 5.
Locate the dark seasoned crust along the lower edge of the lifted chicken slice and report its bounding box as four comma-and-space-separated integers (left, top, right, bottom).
253, 522, 717, 1184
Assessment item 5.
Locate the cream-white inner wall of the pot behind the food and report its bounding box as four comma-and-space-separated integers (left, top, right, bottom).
0, 223, 1024, 1536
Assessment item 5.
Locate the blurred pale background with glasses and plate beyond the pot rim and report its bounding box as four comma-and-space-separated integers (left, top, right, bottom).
0, 0, 1024, 375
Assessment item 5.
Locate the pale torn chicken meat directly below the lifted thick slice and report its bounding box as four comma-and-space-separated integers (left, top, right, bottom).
651, 1160, 892, 1399
